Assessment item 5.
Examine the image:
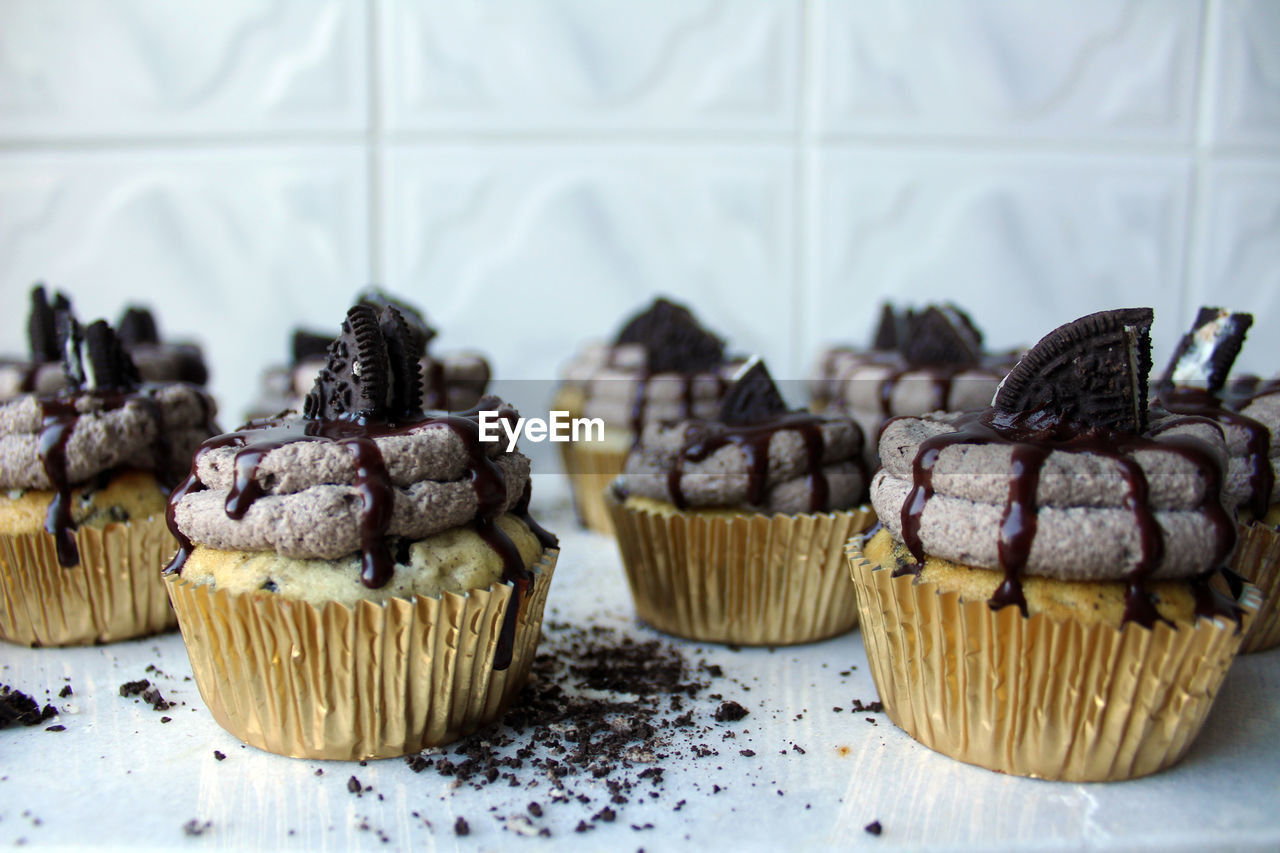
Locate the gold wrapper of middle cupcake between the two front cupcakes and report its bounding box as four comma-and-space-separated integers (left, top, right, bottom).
604, 494, 876, 646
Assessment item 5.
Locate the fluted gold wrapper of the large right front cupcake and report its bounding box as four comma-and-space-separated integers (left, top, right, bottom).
849, 542, 1260, 781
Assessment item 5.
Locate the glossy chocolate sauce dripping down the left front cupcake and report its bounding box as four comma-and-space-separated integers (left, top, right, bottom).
165, 400, 557, 669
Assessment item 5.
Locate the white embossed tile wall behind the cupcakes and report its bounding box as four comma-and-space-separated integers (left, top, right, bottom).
0, 0, 1280, 425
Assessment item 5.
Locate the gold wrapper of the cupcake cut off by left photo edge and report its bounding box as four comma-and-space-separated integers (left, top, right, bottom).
0, 516, 178, 646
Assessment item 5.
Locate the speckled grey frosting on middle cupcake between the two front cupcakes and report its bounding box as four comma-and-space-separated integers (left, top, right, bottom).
621, 416, 867, 514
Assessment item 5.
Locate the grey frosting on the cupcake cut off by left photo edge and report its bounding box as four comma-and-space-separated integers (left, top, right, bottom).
0, 383, 215, 489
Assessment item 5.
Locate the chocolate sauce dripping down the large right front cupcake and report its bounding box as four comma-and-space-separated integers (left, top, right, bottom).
901, 410, 1235, 628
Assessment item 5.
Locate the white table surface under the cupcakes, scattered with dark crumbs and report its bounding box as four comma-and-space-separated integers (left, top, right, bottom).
0, 476, 1280, 853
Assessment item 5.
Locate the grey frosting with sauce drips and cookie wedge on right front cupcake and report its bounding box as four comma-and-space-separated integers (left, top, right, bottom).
872, 309, 1235, 626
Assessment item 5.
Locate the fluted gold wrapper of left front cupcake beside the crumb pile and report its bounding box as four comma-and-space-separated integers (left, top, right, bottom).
165, 549, 559, 760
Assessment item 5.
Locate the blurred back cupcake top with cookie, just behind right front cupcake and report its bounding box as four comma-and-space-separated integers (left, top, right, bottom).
809, 304, 1018, 456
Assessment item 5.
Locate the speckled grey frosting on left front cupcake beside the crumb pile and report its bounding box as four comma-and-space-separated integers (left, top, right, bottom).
174, 412, 529, 560
